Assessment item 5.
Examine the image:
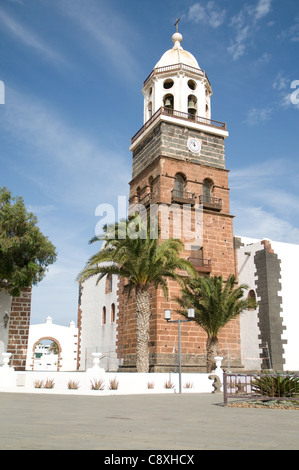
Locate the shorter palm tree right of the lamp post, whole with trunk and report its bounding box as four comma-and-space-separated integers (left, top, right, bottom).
177, 275, 256, 372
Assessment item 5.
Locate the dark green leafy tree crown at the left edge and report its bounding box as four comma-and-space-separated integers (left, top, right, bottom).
0, 187, 56, 296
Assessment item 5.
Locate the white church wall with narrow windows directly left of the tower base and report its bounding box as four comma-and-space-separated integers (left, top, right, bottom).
79, 276, 118, 370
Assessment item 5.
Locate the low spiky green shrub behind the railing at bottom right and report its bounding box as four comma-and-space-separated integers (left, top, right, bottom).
251, 373, 299, 397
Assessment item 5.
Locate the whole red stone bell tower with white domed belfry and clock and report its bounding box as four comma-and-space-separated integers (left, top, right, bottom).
117, 26, 240, 371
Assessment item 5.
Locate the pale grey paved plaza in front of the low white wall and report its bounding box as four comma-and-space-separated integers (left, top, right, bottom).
0, 393, 299, 450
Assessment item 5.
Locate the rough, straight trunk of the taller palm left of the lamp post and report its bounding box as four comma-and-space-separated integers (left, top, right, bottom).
135, 288, 151, 372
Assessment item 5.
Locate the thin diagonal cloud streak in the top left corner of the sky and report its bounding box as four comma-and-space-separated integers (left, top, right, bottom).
0, 9, 67, 65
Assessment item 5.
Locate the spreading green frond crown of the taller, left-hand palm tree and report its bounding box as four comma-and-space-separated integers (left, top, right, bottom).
78, 217, 196, 296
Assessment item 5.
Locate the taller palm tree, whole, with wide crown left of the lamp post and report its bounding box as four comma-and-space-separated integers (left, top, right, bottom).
78, 218, 195, 372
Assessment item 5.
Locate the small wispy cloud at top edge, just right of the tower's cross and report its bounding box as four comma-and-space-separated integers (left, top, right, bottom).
188, 0, 226, 28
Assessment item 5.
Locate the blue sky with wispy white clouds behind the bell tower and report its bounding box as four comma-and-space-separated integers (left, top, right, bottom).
0, 0, 299, 325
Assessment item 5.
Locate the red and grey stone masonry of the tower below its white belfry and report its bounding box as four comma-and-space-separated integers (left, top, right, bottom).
117, 124, 241, 371
